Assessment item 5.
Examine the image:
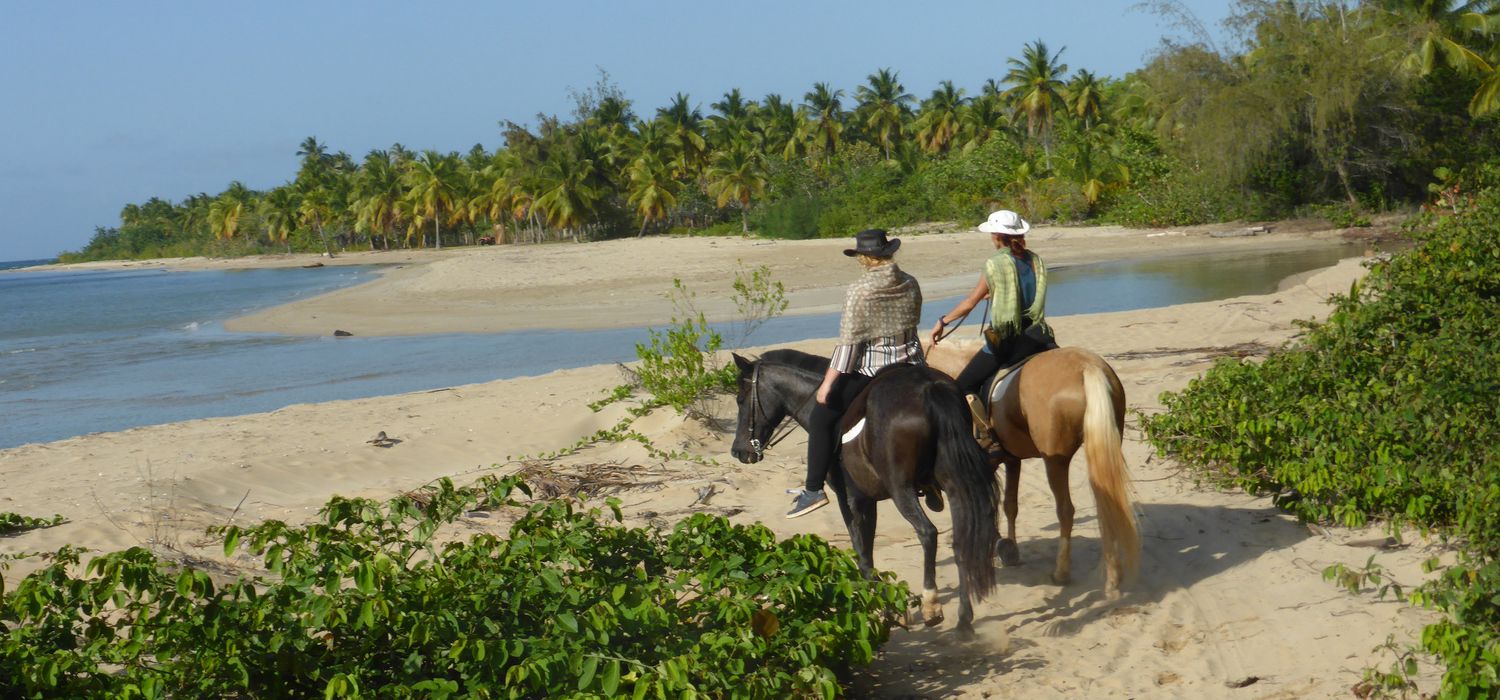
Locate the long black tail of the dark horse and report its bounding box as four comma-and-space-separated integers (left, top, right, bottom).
924, 381, 999, 600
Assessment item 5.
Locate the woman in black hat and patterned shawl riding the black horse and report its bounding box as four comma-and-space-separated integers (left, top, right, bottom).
786, 229, 924, 517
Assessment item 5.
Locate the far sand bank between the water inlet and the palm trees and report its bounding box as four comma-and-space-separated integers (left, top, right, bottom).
24, 222, 1374, 336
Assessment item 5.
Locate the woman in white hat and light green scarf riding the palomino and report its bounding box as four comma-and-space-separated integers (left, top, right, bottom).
932, 210, 1056, 447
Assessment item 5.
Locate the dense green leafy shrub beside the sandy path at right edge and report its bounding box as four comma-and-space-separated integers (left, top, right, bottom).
1143, 171, 1500, 697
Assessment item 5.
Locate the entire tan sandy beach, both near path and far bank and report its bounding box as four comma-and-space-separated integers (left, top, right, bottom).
0, 226, 1439, 699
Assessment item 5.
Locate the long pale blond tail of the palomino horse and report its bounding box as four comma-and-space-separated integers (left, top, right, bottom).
1083, 363, 1140, 576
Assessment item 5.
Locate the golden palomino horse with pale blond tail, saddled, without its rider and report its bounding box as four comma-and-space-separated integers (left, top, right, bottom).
926, 342, 1140, 598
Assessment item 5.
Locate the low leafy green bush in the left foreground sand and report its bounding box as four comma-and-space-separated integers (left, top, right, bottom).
0, 478, 908, 699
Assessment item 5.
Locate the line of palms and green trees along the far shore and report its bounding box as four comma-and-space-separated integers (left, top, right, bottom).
65, 0, 1500, 259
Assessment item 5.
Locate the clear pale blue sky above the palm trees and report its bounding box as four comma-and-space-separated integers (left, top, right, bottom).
0, 0, 1230, 261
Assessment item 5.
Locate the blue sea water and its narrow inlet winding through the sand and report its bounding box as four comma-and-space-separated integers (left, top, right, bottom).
0, 247, 1352, 448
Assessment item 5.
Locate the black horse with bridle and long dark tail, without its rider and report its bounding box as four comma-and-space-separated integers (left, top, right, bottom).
731, 349, 999, 634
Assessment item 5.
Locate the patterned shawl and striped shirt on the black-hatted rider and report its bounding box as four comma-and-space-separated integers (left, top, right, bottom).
833, 262, 926, 376
